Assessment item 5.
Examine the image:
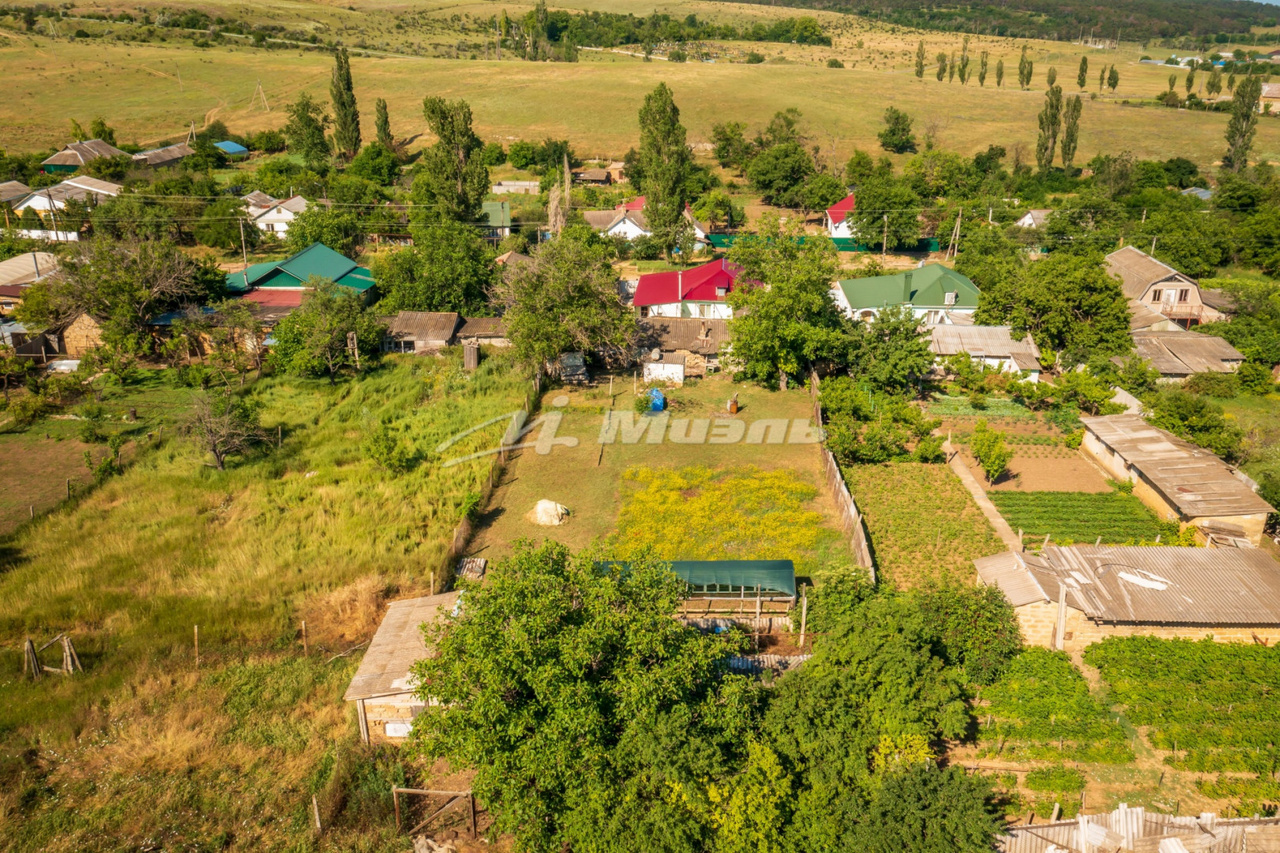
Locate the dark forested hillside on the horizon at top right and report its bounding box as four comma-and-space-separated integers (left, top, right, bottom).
721, 0, 1277, 41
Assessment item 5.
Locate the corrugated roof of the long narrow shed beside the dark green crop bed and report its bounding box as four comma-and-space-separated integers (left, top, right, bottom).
1080, 415, 1275, 519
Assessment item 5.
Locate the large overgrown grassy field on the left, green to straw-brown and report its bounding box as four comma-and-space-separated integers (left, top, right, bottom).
0, 355, 527, 850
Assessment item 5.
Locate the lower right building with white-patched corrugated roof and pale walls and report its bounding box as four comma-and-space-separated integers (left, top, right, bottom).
974, 544, 1280, 653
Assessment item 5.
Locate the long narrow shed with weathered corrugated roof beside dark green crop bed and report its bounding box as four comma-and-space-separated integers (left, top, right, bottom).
1080, 415, 1276, 546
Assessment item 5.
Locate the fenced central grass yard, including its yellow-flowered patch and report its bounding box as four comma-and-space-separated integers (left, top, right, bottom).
470, 375, 840, 578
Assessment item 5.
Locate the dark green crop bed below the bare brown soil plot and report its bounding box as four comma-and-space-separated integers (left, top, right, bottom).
987, 491, 1178, 544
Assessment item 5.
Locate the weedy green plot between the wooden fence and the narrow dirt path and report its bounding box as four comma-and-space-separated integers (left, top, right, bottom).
844, 462, 1004, 588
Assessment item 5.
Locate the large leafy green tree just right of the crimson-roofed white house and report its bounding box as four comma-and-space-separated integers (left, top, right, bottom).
727, 215, 845, 387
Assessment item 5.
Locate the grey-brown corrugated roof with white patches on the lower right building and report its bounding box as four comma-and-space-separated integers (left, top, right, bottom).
993, 546, 1280, 628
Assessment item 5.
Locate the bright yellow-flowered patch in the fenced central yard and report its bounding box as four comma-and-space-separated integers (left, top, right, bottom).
614, 466, 850, 574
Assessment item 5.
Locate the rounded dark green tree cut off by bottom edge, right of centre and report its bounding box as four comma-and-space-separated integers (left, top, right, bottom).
849, 763, 1004, 853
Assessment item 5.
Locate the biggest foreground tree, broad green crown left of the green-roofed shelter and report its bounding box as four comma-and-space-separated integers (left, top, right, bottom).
411, 543, 747, 853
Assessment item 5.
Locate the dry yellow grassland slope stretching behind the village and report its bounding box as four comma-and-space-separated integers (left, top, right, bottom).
0, 0, 1280, 167
